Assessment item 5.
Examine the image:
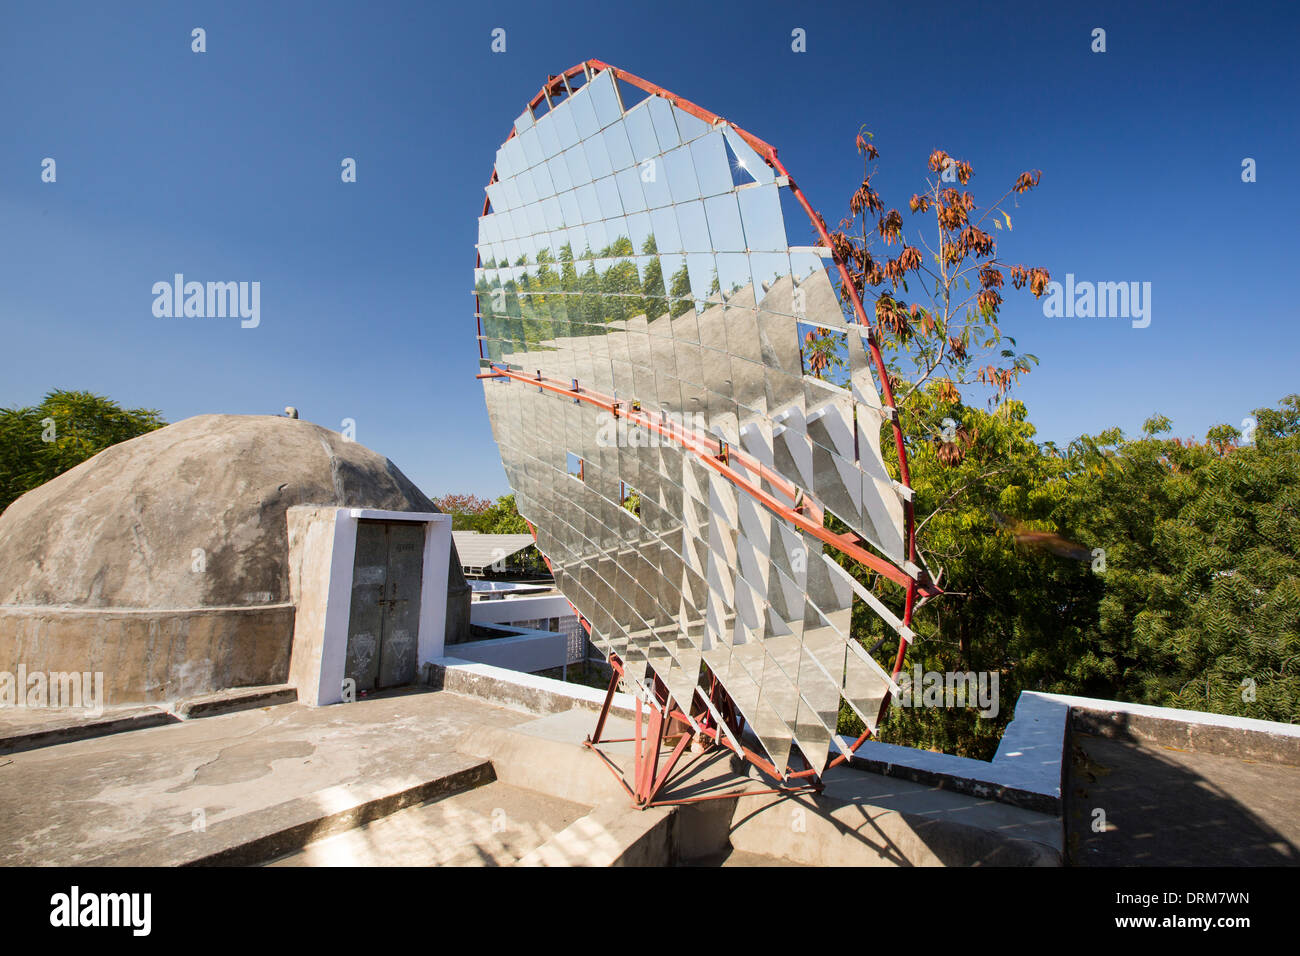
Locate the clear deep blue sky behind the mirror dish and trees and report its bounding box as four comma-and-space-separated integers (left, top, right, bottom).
0, 0, 1300, 496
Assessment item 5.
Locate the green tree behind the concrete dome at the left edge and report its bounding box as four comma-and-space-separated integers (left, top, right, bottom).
0, 390, 166, 511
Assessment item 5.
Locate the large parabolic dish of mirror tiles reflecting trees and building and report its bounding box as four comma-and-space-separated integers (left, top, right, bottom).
475, 61, 920, 775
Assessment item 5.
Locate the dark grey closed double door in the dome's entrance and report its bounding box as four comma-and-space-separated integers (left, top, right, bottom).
343, 519, 425, 693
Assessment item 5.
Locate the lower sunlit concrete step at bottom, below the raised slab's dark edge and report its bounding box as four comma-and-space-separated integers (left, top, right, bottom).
268, 780, 588, 866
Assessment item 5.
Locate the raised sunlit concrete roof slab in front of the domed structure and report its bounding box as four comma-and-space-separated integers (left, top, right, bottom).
0, 692, 517, 866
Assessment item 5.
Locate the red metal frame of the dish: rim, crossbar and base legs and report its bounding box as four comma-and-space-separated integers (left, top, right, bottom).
475, 60, 941, 806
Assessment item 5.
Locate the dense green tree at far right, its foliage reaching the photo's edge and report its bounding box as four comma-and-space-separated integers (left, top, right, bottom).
1057, 395, 1300, 722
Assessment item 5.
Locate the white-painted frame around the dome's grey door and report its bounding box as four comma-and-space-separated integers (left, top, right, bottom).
299, 507, 451, 706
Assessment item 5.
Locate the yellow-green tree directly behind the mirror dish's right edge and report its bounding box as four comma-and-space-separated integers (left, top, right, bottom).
839, 384, 1101, 760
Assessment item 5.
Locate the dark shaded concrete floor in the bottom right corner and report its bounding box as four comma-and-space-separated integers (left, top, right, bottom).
1066, 734, 1300, 866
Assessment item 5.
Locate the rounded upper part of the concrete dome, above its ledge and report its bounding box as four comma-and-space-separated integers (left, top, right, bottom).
0, 415, 468, 609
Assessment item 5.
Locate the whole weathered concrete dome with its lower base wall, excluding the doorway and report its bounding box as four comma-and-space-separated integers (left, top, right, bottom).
0, 415, 471, 704
